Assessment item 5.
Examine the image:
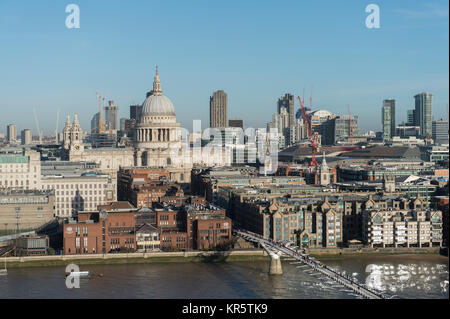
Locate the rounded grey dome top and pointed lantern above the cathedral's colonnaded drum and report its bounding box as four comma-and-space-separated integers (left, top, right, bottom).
141, 67, 175, 116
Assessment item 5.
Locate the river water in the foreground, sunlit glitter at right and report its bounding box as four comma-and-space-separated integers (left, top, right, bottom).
0, 255, 449, 299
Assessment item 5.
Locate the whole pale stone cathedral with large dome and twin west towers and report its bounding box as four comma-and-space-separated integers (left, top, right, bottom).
63, 68, 231, 183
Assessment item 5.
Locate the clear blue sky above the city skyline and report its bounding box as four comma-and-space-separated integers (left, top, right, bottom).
0, 0, 449, 134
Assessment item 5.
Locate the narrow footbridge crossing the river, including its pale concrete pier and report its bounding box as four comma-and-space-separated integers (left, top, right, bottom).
233, 229, 389, 299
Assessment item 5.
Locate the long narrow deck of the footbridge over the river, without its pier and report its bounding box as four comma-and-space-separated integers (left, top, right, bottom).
234, 230, 387, 299
